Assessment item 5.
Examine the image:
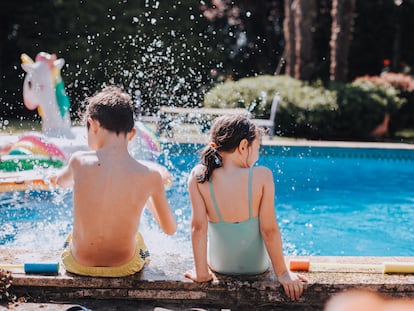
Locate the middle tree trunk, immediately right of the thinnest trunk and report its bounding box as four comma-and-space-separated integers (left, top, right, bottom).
294, 0, 316, 80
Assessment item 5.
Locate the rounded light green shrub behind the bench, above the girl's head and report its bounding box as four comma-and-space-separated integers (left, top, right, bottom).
204, 75, 335, 137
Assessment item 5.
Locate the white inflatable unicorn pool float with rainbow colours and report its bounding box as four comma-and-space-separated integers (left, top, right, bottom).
0, 52, 171, 192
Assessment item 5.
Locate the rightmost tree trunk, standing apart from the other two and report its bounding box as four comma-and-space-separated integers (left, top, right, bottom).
330, 0, 355, 81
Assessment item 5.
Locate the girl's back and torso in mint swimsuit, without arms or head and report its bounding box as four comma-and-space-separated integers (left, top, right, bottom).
199, 168, 269, 274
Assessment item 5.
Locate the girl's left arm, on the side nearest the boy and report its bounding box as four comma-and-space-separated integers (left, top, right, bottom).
184, 170, 213, 282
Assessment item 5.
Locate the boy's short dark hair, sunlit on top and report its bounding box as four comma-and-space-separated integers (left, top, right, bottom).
85, 86, 134, 135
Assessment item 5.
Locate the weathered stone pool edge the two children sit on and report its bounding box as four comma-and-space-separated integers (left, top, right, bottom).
0, 249, 414, 310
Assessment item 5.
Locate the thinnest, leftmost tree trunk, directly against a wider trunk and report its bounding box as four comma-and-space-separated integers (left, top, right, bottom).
283, 0, 296, 77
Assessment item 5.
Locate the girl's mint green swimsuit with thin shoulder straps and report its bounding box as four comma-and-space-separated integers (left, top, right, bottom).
208, 168, 269, 275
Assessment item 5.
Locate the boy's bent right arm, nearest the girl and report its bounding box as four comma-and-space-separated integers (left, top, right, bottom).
147, 171, 177, 235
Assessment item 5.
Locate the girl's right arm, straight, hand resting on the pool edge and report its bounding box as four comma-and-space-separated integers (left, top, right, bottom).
257, 167, 308, 300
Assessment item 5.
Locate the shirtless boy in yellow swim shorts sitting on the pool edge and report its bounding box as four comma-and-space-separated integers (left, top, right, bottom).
56, 87, 176, 277
